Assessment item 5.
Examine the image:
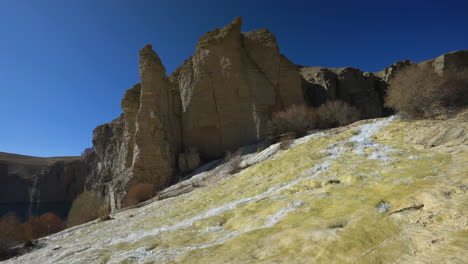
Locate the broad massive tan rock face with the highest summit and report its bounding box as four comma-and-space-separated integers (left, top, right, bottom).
170, 18, 303, 159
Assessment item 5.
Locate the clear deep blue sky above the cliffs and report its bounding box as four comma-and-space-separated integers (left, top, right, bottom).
0, 0, 468, 156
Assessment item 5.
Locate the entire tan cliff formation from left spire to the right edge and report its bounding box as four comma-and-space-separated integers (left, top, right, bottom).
86, 18, 468, 207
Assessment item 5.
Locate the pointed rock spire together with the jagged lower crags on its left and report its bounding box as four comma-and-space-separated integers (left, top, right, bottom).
86, 45, 184, 207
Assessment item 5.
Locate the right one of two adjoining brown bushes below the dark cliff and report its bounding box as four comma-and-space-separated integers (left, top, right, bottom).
316, 100, 362, 128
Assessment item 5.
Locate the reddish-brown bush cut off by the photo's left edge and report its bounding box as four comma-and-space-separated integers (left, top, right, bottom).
0, 213, 29, 260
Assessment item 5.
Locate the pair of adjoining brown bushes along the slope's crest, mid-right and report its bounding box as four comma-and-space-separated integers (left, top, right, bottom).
268, 100, 361, 141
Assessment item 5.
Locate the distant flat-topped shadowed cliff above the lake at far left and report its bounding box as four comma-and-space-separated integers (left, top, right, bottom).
0, 152, 88, 204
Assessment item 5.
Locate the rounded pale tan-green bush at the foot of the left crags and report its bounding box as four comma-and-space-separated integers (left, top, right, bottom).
67, 191, 104, 227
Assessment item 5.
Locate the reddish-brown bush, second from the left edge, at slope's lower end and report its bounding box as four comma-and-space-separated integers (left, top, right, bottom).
23, 213, 66, 239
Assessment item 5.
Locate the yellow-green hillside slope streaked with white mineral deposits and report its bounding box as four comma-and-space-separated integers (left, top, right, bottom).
6, 111, 468, 264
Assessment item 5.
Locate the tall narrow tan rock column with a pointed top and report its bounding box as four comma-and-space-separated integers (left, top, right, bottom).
132, 45, 178, 189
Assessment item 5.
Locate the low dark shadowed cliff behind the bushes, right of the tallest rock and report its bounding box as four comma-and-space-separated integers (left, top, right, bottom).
299, 50, 468, 118
